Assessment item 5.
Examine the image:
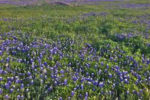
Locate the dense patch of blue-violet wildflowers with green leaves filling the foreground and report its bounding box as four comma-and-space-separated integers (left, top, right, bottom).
0, 33, 150, 100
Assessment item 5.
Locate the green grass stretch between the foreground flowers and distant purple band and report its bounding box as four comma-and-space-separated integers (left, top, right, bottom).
0, 2, 150, 54
